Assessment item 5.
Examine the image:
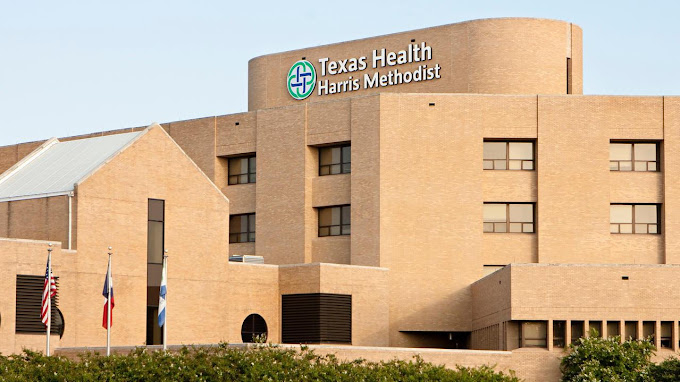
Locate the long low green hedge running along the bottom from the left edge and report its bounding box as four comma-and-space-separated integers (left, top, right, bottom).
0, 344, 519, 382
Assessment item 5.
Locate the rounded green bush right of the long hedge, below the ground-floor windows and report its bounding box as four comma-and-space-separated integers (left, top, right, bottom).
560, 332, 655, 382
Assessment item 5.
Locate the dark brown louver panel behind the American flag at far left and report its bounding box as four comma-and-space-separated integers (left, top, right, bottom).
15, 275, 63, 334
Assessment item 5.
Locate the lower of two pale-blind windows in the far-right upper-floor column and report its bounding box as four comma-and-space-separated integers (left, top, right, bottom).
609, 204, 661, 234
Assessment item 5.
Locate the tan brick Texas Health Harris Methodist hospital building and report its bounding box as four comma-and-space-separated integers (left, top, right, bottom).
0, 18, 680, 380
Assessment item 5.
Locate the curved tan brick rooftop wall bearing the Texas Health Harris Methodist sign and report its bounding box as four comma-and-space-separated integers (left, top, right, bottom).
248, 18, 583, 110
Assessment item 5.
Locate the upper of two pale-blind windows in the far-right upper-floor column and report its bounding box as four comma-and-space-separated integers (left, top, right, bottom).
609, 142, 659, 171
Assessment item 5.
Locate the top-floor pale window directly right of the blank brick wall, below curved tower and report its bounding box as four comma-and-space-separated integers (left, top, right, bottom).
484, 141, 534, 170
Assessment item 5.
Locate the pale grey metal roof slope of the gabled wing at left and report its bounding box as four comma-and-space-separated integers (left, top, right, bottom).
0, 130, 146, 202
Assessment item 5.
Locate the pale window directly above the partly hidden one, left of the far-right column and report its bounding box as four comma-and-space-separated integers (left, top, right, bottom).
484, 203, 534, 233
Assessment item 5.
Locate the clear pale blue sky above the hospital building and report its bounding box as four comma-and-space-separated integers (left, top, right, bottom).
0, 0, 680, 145
